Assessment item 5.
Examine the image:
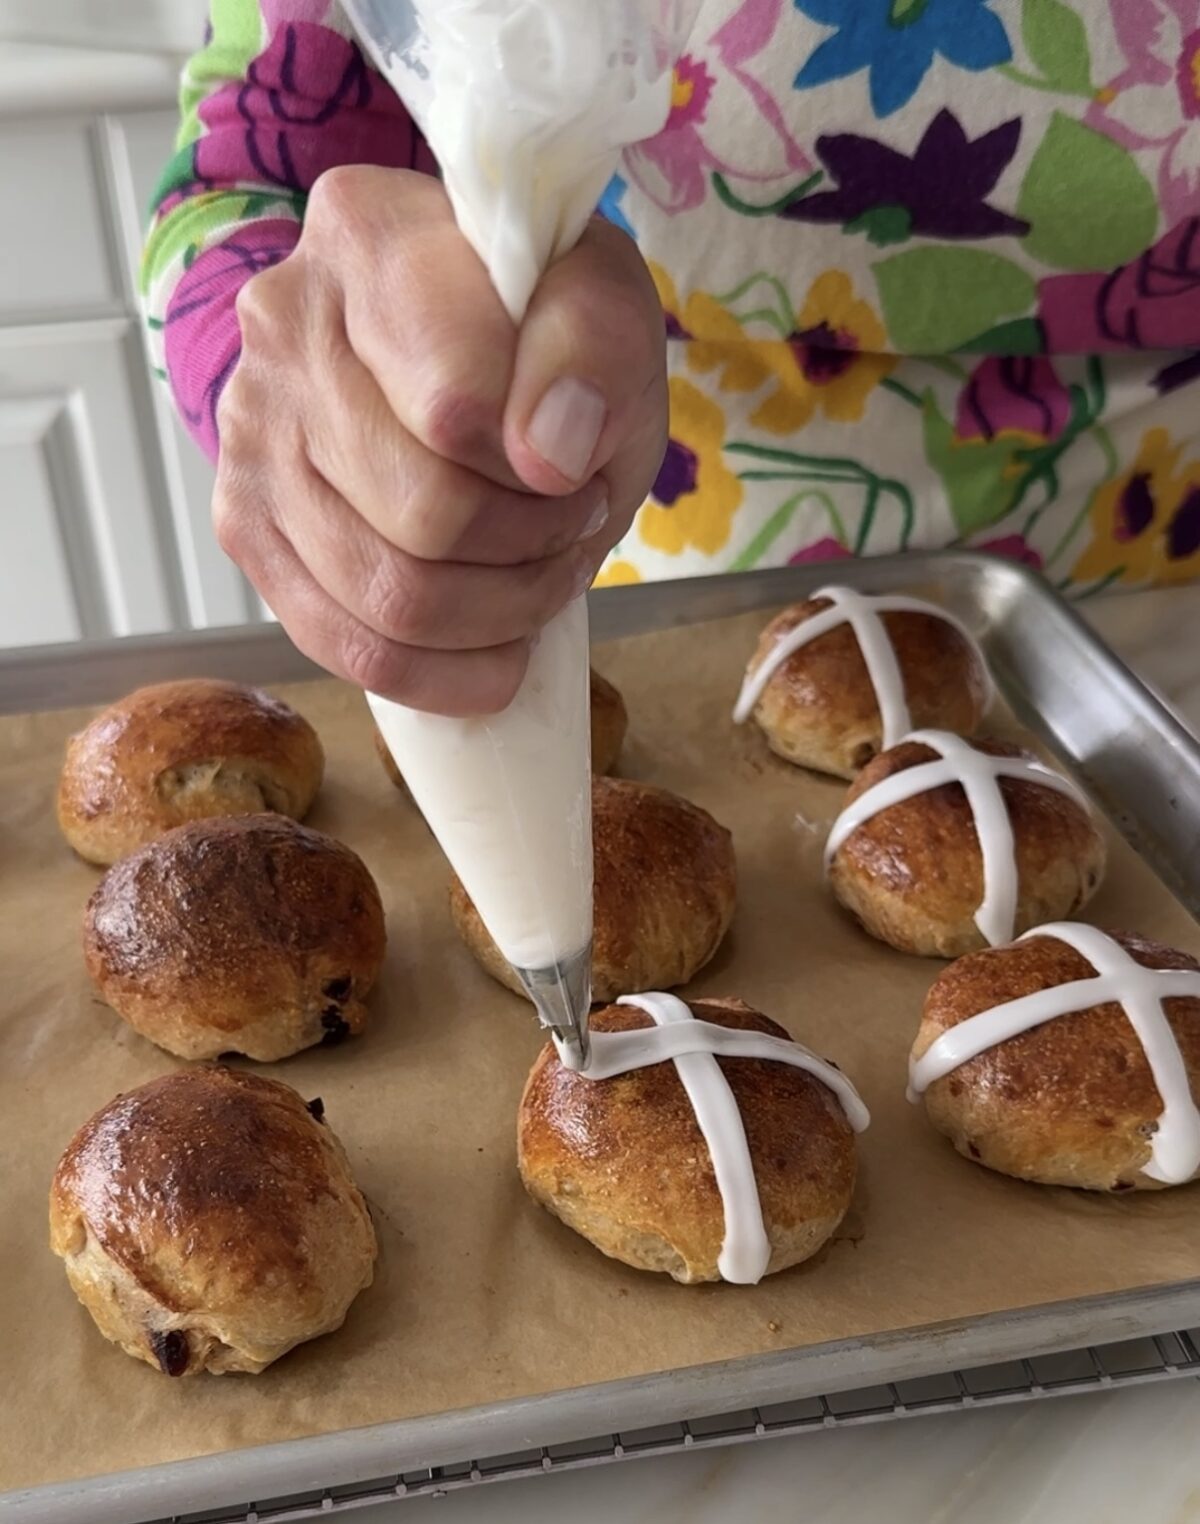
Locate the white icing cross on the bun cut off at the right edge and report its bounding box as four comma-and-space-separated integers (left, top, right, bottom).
909, 920, 1200, 1186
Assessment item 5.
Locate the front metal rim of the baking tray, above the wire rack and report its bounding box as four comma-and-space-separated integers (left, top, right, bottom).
9, 1279, 1200, 1524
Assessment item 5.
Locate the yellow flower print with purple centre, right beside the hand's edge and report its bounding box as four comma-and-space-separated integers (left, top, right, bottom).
637, 376, 744, 556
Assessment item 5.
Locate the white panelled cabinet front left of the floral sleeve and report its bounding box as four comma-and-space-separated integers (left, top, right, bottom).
0, 108, 262, 646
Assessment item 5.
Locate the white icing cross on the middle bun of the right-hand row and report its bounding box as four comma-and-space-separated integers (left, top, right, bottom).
825, 730, 1090, 946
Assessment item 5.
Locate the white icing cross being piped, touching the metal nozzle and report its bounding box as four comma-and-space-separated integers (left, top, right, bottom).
558, 994, 871, 1286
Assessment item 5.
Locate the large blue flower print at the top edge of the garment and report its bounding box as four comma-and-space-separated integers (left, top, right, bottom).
796, 0, 1012, 116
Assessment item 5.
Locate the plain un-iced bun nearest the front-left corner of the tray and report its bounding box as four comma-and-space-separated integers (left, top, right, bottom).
50, 1068, 377, 1376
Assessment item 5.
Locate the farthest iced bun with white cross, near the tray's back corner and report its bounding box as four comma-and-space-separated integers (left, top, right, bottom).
733, 587, 993, 777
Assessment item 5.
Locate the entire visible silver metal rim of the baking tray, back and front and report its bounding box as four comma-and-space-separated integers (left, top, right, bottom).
0, 552, 1200, 1524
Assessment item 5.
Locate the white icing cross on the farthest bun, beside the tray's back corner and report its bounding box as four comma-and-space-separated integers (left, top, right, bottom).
733, 587, 993, 750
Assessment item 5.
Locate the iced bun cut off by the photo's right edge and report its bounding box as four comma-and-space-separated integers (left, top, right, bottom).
909, 922, 1200, 1190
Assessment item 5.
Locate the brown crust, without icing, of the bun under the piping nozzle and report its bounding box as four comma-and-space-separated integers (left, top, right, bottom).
517, 1000, 857, 1283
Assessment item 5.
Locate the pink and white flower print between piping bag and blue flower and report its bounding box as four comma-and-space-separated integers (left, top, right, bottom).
625, 0, 811, 213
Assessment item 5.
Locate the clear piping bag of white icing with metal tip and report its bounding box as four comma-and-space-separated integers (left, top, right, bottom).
345, 0, 698, 1068
